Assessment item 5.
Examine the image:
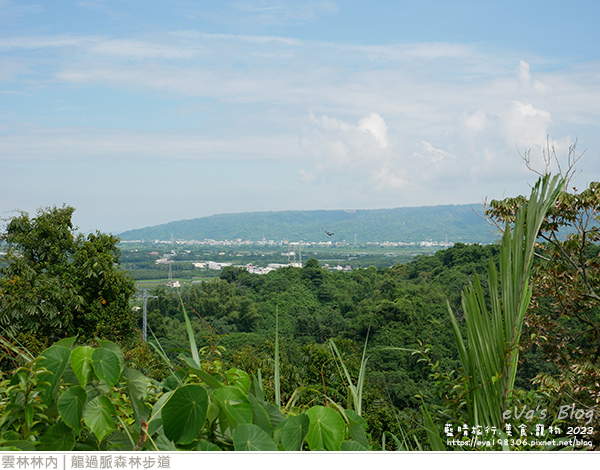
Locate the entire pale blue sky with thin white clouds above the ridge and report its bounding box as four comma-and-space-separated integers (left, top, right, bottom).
0, 0, 600, 233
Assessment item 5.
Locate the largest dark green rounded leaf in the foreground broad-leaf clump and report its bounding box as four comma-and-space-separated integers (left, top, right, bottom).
161, 384, 208, 444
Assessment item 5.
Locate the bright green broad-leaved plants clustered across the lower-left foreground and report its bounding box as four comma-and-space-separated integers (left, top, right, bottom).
0, 320, 371, 452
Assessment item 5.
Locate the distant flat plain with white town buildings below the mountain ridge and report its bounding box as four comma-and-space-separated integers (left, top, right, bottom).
120, 238, 454, 287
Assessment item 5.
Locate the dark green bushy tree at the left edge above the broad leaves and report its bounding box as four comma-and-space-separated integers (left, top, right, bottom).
0, 206, 135, 342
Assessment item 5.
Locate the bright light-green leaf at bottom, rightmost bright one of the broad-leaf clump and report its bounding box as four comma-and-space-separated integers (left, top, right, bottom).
306, 406, 346, 451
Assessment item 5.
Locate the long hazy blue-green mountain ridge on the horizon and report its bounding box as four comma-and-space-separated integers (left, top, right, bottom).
119, 204, 498, 244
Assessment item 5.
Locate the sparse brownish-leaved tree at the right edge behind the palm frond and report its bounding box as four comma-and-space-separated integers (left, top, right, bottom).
486, 147, 600, 445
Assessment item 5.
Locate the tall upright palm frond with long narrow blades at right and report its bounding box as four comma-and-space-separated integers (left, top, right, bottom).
448, 175, 565, 427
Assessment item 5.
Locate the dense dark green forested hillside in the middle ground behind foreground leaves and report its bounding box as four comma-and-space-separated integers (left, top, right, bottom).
141, 244, 506, 441
